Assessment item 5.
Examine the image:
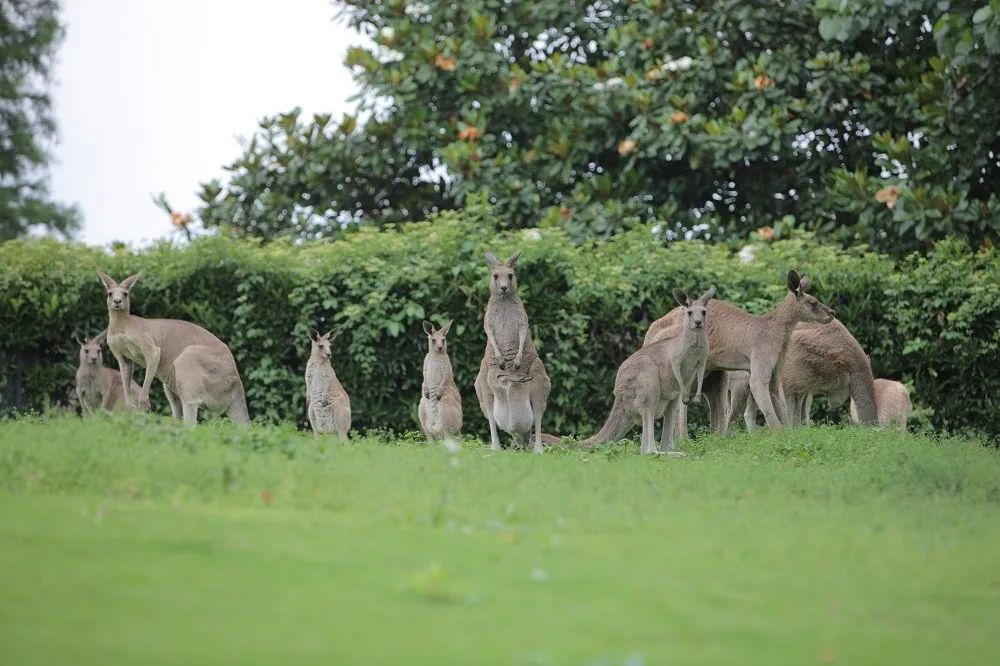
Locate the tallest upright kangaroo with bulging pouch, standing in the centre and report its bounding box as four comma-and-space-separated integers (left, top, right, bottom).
476, 252, 552, 453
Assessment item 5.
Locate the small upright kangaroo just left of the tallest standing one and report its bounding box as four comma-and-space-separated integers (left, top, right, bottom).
417, 321, 462, 439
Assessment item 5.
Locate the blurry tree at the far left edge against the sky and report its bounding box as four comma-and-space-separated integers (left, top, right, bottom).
0, 0, 79, 241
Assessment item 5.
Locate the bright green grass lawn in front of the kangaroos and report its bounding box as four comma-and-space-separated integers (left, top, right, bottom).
0, 415, 1000, 665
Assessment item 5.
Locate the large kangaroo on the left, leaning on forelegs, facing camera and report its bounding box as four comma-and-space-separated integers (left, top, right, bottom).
97, 271, 250, 425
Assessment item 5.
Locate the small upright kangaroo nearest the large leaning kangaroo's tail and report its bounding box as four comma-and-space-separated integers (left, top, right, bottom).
306, 329, 351, 441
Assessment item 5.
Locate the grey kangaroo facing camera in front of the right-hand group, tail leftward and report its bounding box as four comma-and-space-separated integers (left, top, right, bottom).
580, 287, 715, 454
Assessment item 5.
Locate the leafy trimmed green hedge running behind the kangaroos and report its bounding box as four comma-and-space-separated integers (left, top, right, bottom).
0, 208, 1000, 434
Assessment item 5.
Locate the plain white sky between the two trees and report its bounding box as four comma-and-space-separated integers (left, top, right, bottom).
51, 0, 363, 245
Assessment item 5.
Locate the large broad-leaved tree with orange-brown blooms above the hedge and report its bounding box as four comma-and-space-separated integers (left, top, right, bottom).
202, 0, 1000, 252
